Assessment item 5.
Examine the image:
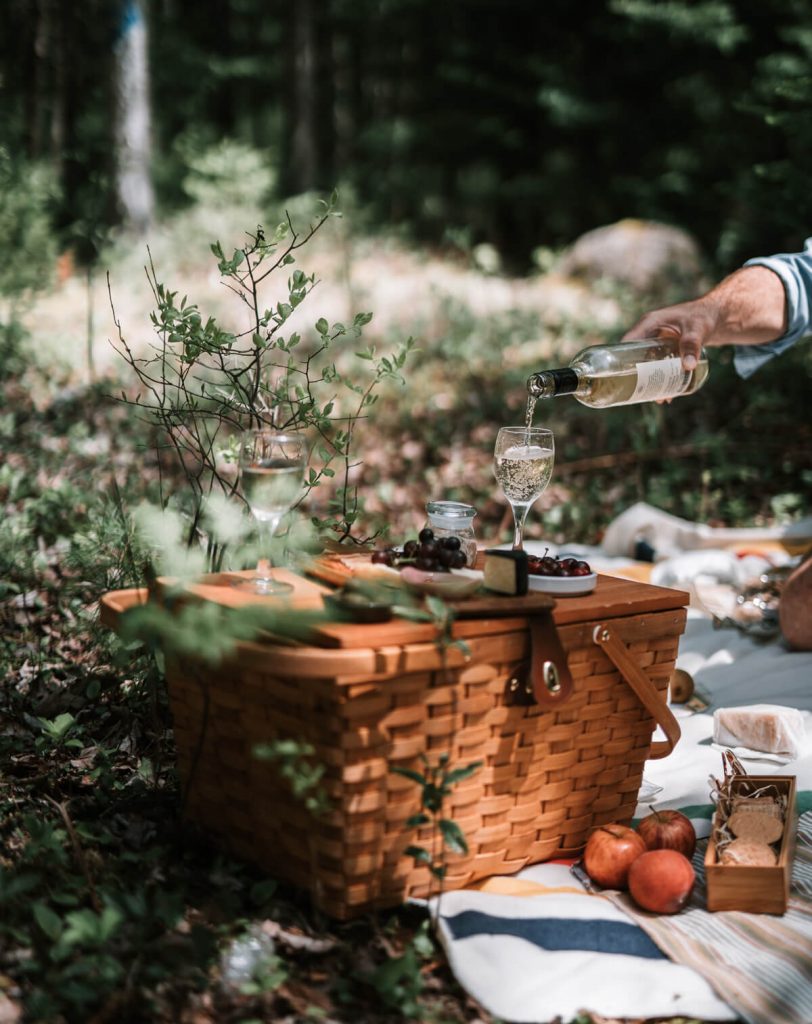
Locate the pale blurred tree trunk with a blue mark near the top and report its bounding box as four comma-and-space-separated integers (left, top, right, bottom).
115, 0, 155, 233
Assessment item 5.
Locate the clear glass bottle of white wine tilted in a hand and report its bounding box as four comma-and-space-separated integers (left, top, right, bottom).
527, 338, 708, 409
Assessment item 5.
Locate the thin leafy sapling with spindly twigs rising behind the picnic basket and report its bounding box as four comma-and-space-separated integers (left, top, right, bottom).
108, 195, 414, 568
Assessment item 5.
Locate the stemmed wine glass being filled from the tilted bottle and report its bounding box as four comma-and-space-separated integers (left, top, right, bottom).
494, 427, 555, 551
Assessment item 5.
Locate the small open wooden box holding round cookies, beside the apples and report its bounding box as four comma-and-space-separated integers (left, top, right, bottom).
704, 775, 798, 913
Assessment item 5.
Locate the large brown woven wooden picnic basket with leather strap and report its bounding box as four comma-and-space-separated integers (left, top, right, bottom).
102, 577, 687, 919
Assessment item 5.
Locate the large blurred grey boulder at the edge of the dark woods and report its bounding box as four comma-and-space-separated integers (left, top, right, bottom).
557, 218, 704, 301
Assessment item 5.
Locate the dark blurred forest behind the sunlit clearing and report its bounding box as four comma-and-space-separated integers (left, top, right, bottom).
0, 0, 812, 270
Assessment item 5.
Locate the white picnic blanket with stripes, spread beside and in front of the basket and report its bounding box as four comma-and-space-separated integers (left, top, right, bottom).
432, 509, 812, 1024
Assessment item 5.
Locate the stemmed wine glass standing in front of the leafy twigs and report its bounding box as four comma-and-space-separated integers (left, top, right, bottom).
234, 429, 307, 596
